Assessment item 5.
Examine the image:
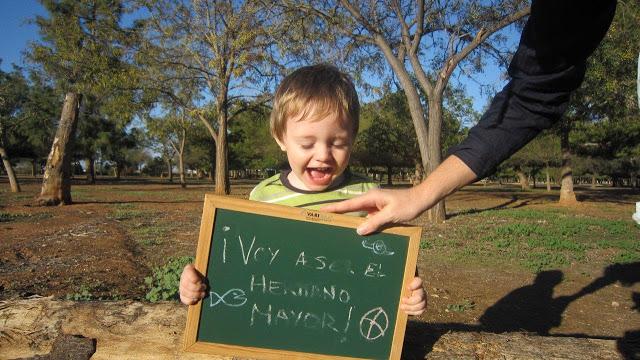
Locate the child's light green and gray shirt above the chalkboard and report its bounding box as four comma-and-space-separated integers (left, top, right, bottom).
249, 170, 378, 217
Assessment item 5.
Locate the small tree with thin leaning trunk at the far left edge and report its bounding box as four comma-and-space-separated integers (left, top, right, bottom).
0, 66, 28, 192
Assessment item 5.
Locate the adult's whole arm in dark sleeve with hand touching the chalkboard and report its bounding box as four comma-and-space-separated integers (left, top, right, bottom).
321, 0, 616, 235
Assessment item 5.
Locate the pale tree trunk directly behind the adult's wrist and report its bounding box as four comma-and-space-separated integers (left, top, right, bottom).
427, 97, 447, 223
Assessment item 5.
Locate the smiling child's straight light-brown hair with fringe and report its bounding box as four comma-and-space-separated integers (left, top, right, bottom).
271, 64, 360, 140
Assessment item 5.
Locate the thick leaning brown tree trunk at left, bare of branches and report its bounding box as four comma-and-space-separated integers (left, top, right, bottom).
37, 92, 82, 206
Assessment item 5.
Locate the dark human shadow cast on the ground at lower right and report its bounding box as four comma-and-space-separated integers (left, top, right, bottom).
402, 262, 640, 359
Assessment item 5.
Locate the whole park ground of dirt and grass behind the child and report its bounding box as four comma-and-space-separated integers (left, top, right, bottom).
0, 179, 640, 352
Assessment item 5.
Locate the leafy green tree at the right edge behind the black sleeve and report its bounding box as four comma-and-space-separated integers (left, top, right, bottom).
560, 1, 640, 203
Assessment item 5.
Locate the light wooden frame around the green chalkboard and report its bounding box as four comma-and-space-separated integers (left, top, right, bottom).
183, 194, 422, 360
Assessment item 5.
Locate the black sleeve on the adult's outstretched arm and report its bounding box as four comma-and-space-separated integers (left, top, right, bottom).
449, 0, 616, 179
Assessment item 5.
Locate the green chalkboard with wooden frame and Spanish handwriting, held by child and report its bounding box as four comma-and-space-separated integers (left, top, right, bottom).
185, 195, 421, 359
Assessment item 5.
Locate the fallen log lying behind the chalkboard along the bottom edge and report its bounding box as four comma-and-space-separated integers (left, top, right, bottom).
0, 297, 622, 360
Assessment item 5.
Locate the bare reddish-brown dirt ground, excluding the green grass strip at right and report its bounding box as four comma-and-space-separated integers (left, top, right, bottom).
0, 179, 640, 354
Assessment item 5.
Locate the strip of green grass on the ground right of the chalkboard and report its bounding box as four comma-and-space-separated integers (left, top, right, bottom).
430, 208, 640, 272
